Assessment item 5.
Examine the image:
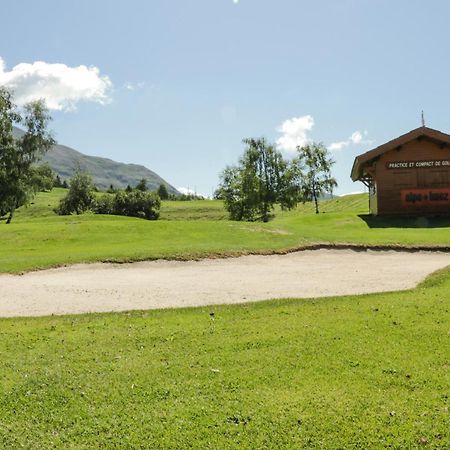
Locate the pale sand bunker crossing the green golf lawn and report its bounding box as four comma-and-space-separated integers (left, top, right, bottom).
0, 250, 450, 317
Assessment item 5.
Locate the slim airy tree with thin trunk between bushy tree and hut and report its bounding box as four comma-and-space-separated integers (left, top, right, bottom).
292, 142, 337, 214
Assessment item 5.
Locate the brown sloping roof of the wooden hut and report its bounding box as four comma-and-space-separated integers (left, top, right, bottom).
351, 127, 450, 181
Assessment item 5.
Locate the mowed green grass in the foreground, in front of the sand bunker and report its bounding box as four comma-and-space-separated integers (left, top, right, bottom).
0, 269, 450, 449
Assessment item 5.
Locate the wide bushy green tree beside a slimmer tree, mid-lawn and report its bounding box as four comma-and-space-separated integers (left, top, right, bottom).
216, 138, 297, 222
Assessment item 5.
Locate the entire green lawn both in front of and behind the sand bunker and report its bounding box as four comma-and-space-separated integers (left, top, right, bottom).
0, 190, 450, 449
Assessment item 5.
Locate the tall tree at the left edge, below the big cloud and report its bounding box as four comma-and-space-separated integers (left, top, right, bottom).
0, 88, 55, 223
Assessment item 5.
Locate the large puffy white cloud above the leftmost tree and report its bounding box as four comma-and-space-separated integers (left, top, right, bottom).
0, 57, 112, 111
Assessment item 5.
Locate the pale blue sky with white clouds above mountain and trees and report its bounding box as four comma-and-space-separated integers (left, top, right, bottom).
0, 0, 450, 195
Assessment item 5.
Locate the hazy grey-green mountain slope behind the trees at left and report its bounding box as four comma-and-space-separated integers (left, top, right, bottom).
14, 128, 180, 195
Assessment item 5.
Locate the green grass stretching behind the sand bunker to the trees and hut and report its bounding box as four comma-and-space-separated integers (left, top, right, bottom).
0, 189, 450, 273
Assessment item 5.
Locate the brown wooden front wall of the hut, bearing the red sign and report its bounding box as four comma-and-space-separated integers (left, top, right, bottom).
372, 138, 450, 215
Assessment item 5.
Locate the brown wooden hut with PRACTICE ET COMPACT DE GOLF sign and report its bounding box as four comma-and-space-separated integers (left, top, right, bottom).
351, 126, 450, 216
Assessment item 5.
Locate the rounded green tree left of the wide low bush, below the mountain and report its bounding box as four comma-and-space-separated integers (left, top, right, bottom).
57, 170, 95, 215
